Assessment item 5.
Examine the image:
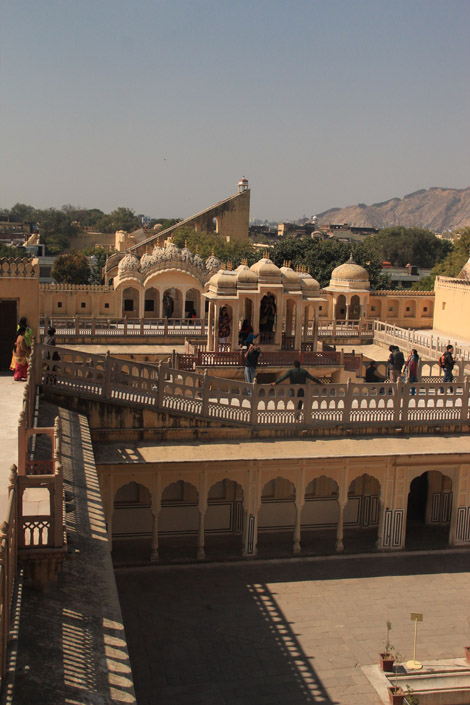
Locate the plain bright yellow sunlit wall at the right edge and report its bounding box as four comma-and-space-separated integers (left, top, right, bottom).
433, 277, 470, 339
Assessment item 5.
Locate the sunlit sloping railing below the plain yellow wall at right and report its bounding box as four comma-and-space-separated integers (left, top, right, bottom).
374, 321, 470, 362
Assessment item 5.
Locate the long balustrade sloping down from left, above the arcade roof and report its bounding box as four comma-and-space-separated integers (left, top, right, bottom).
39, 346, 470, 430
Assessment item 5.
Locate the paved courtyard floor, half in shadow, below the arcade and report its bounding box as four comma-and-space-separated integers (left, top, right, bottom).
116, 550, 470, 705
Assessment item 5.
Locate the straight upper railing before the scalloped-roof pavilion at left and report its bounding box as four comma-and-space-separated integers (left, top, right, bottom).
39, 316, 206, 338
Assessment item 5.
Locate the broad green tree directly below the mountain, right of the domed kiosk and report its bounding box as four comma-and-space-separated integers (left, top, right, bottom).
366, 226, 450, 267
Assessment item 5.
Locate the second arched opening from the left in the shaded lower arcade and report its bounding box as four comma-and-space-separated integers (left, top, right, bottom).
158, 480, 199, 561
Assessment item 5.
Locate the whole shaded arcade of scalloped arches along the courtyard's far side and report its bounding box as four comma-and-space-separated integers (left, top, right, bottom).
98, 446, 470, 560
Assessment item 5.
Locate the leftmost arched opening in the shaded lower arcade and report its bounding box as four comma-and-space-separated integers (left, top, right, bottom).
112, 482, 153, 563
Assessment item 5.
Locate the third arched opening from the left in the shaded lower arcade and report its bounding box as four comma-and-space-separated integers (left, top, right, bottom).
204, 479, 243, 558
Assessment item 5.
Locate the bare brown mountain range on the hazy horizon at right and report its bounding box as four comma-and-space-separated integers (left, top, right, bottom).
317, 187, 470, 232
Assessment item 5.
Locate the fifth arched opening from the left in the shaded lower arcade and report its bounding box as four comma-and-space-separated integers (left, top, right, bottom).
300, 475, 339, 555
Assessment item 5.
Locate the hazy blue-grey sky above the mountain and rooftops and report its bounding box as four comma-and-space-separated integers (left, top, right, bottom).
0, 0, 470, 220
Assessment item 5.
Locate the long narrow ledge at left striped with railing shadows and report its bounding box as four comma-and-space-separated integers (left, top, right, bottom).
8, 409, 136, 705
